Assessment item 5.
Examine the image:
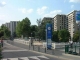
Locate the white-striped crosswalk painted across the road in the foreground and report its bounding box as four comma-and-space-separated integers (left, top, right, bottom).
2, 56, 49, 60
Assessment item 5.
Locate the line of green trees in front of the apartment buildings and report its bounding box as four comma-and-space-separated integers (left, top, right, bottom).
0, 17, 79, 42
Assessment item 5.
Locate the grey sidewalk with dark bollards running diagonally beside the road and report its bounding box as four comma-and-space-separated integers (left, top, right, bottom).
8, 39, 80, 60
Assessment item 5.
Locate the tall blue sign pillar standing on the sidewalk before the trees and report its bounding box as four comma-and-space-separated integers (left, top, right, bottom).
46, 23, 52, 49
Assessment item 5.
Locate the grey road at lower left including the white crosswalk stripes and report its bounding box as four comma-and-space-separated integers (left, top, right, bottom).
2, 41, 66, 60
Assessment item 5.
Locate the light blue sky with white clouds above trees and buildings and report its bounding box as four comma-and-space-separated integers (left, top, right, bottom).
0, 0, 80, 25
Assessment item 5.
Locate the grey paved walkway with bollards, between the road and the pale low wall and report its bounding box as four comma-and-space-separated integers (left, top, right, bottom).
8, 41, 80, 60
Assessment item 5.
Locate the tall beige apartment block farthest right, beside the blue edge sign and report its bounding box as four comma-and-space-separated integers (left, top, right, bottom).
67, 10, 78, 39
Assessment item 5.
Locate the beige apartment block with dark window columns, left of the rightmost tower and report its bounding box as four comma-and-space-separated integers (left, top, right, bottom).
53, 14, 68, 31
